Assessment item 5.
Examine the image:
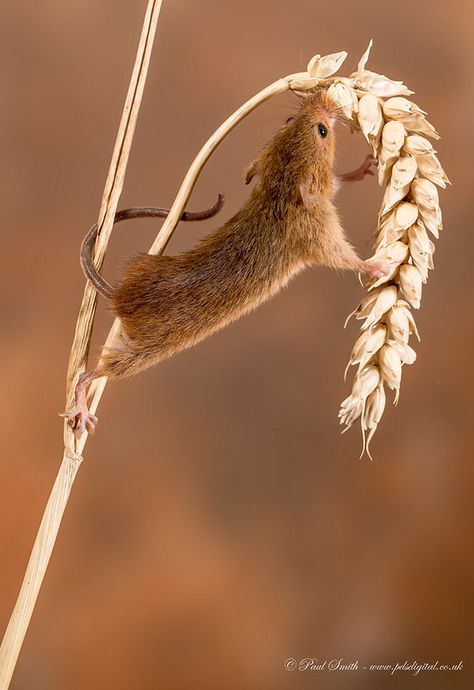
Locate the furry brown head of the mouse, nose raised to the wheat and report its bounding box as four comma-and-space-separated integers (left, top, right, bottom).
259, 89, 339, 208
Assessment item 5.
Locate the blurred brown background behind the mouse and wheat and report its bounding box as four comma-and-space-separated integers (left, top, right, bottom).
0, 0, 474, 690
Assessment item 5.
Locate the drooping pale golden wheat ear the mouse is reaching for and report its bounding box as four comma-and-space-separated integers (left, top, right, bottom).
334, 41, 449, 457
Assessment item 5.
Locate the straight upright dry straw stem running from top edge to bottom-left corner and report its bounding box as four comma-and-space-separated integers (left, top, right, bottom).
0, 0, 161, 690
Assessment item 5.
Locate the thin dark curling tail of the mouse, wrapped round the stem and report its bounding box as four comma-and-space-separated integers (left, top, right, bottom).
81, 194, 224, 299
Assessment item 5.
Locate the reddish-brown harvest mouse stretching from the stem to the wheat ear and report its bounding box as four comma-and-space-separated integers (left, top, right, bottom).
64, 90, 388, 436
